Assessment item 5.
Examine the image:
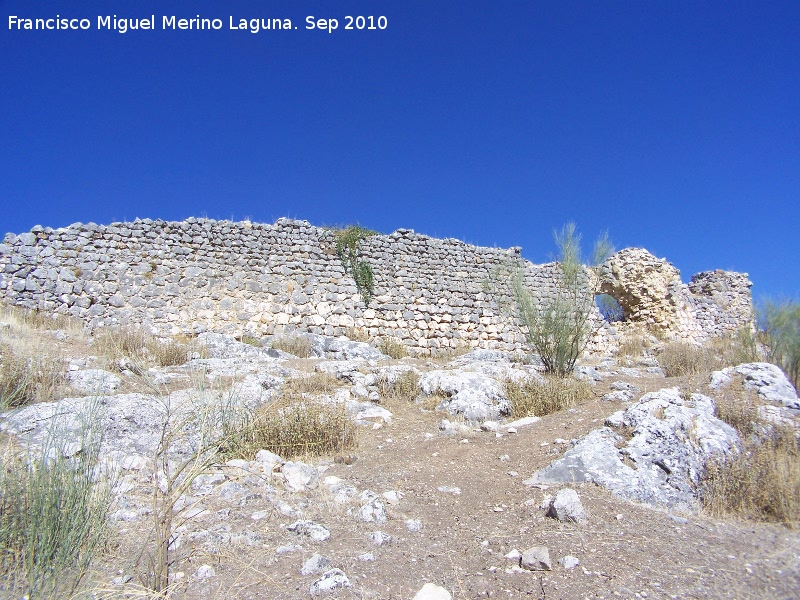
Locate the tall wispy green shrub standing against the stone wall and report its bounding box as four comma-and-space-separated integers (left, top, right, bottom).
511, 223, 613, 377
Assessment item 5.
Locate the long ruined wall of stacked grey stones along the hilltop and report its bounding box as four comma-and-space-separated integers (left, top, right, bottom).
0, 219, 751, 353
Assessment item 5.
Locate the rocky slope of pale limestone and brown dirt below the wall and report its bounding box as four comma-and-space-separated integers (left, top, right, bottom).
2, 332, 800, 600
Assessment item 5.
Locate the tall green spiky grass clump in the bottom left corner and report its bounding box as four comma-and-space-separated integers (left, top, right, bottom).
0, 404, 111, 598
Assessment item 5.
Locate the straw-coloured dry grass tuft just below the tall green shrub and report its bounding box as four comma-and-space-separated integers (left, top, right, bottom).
505, 376, 592, 418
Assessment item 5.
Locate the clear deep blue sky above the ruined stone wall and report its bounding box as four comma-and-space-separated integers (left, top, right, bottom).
0, 0, 800, 297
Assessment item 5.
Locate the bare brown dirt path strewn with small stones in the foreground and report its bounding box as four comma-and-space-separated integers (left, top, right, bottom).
120, 390, 800, 600
